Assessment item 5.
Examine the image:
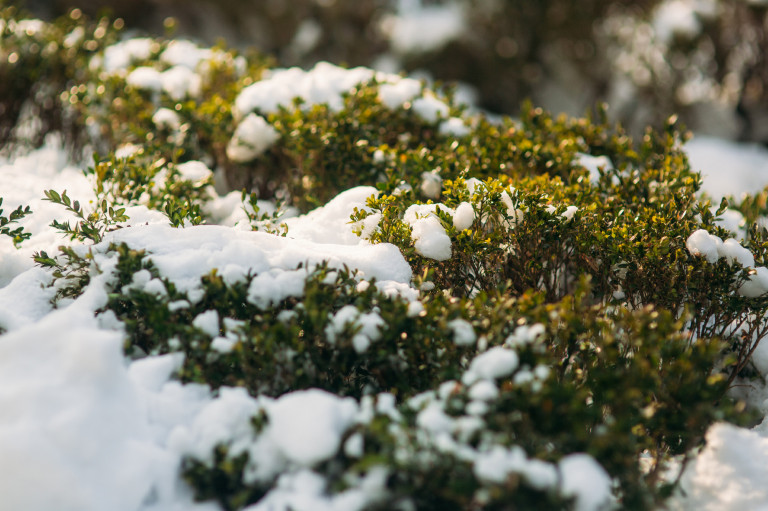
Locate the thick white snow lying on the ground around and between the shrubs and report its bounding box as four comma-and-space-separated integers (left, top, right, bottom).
0, 133, 768, 511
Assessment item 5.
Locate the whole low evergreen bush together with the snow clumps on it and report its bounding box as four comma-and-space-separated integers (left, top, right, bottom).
0, 10, 768, 511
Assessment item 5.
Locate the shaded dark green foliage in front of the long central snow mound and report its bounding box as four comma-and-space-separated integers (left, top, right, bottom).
46, 245, 748, 509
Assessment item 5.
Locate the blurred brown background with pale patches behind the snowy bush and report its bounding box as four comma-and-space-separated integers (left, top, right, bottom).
22, 0, 768, 145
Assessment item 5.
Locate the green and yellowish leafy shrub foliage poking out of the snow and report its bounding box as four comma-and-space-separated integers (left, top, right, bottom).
0, 9, 768, 510
